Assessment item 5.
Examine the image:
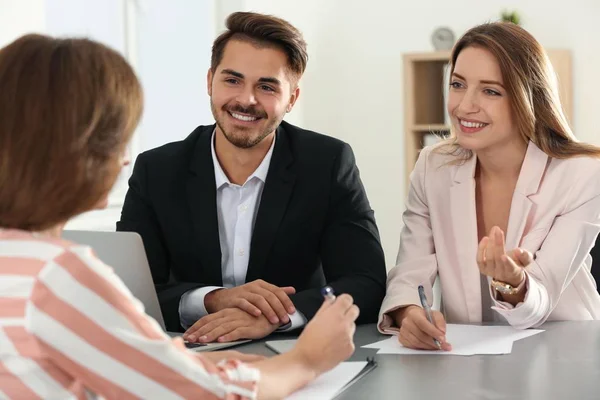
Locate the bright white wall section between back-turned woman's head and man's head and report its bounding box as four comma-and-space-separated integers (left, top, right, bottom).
138, 0, 215, 151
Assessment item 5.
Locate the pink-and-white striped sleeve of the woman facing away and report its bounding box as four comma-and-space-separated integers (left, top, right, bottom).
25, 246, 260, 400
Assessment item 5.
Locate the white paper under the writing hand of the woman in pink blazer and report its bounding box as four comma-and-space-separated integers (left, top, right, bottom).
362, 324, 543, 356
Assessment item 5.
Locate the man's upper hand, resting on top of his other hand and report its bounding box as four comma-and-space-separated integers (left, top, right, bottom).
201, 279, 296, 324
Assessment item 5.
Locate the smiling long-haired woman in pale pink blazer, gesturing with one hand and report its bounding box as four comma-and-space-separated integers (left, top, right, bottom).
378, 23, 600, 350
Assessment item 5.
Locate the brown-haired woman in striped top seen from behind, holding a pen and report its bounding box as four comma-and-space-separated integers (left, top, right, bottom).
0, 35, 358, 399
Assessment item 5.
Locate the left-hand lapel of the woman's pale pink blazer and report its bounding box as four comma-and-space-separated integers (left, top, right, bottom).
448, 155, 481, 322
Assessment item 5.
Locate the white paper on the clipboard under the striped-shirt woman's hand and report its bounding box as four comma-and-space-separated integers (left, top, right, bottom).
286, 361, 367, 400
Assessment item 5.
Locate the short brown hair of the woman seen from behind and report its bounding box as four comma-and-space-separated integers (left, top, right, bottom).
0, 35, 143, 231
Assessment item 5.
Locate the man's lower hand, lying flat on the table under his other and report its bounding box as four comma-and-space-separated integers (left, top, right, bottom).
183, 308, 279, 343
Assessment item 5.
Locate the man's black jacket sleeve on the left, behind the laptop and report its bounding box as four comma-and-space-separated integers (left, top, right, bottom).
117, 154, 205, 332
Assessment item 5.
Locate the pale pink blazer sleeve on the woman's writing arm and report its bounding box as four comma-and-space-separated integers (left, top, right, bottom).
377, 148, 437, 333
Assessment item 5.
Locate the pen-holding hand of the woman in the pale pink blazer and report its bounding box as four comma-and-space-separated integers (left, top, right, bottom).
394, 288, 452, 351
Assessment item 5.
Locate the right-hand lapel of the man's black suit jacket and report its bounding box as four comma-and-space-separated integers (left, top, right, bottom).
246, 126, 296, 282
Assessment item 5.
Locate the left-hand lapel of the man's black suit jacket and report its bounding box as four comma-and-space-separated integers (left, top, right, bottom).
186, 126, 223, 286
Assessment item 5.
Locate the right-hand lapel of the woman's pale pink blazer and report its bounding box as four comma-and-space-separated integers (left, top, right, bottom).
506, 142, 549, 251
